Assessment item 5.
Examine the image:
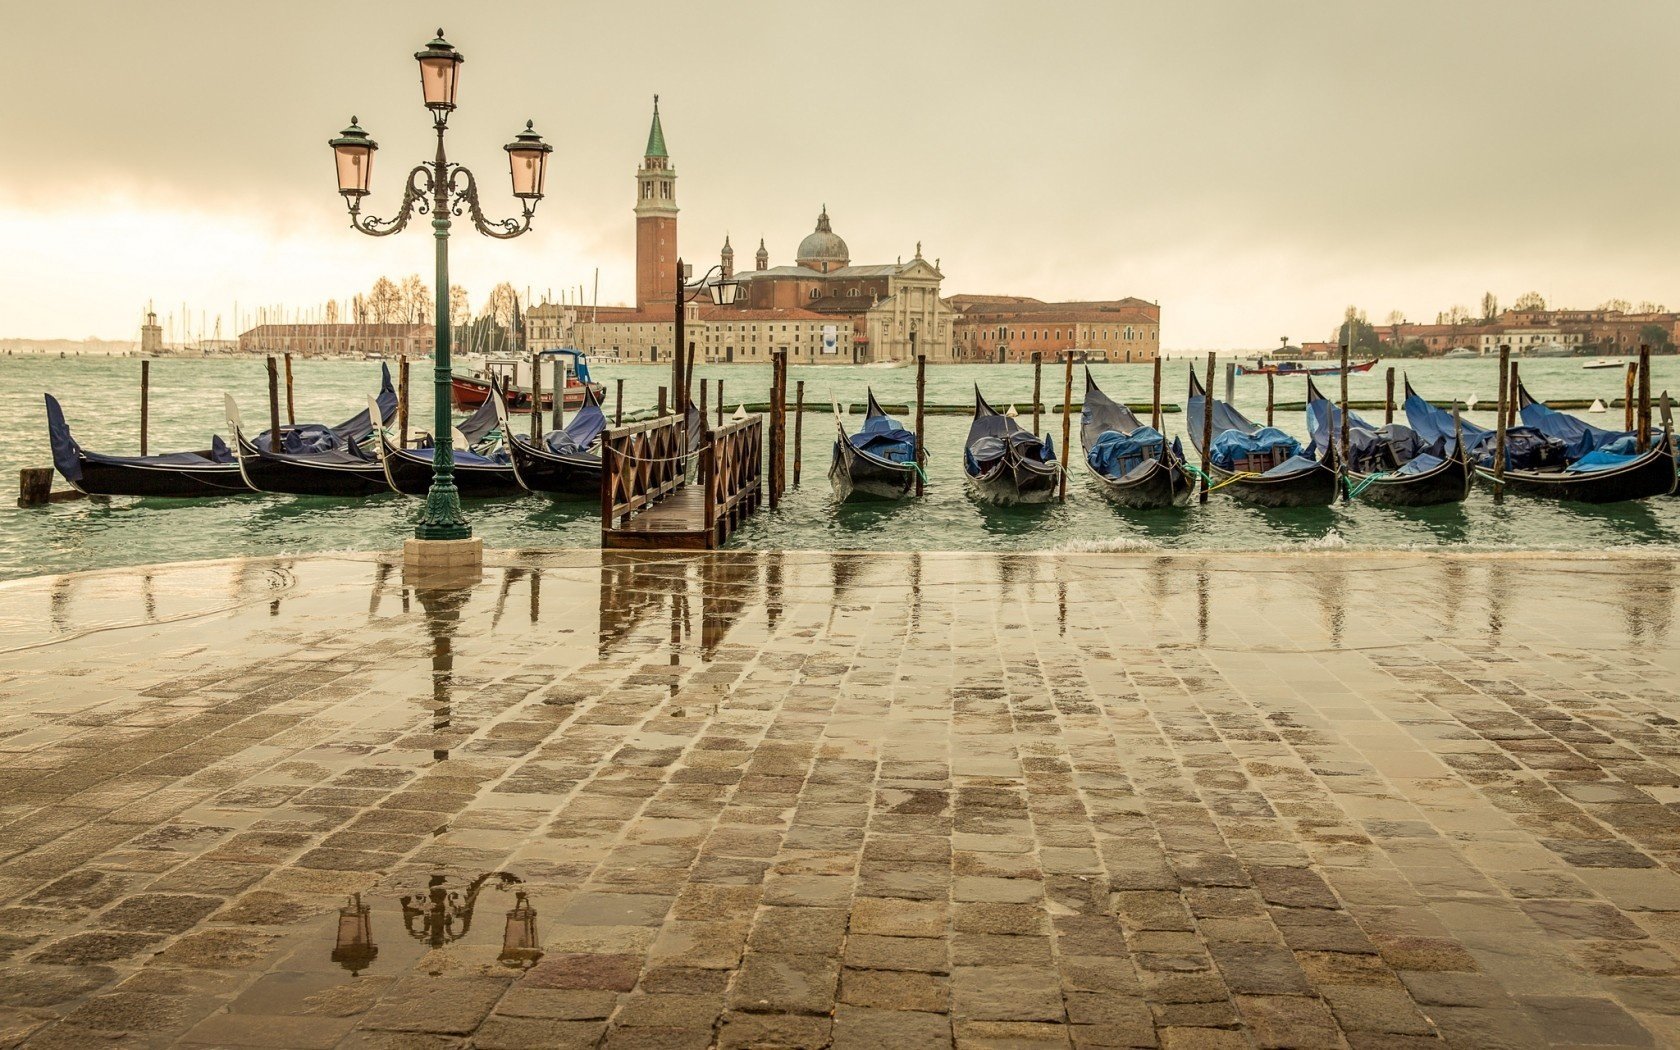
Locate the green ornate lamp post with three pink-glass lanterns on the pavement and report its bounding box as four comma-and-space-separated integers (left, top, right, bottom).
328, 29, 554, 539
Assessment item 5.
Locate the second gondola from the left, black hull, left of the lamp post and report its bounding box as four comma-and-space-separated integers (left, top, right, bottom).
225, 370, 411, 496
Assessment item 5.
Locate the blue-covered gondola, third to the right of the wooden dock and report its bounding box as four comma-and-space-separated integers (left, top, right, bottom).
1079, 368, 1191, 511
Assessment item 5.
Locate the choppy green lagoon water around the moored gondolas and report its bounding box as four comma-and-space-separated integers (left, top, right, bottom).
0, 356, 1680, 578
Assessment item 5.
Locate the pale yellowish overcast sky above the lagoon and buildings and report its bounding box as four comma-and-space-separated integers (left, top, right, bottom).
0, 0, 1680, 349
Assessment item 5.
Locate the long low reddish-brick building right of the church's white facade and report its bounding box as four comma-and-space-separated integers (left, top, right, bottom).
948, 296, 1161, 363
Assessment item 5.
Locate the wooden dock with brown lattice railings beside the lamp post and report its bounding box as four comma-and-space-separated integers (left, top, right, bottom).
601, 415, 764, 551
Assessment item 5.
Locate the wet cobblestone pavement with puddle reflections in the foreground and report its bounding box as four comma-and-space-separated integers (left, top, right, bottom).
0, 551, 1680, 1050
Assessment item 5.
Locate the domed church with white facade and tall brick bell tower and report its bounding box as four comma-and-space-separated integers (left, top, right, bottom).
570, 97, 956, 365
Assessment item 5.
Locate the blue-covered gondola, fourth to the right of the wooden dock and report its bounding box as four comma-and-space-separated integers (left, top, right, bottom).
1184, 370, 1341, 507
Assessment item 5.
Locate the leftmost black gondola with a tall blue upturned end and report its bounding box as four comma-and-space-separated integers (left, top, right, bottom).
44, 393, 250, 499
